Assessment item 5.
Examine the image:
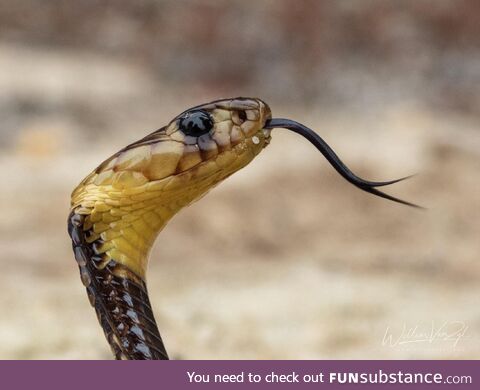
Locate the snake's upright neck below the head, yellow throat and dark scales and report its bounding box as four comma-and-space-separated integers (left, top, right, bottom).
68, 174, 189, 360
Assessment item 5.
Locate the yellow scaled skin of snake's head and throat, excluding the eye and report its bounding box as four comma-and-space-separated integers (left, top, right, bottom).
71, 98, 271, 280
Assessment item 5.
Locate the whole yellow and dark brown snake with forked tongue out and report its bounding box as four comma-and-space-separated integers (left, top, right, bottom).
68, 97, 420, 360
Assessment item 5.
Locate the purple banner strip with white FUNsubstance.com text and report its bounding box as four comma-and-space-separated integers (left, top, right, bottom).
0, 360, 474, 390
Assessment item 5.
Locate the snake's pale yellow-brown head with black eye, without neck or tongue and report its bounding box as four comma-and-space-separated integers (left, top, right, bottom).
84, 98, 271, 191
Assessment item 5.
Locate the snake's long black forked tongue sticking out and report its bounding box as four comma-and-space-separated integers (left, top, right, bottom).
263, 118, 423, 209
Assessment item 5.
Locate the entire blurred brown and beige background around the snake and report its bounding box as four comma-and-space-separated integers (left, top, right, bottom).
0, 0, 480, 359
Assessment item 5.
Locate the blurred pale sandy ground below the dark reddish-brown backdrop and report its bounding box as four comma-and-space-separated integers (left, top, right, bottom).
0, 45, 480, 359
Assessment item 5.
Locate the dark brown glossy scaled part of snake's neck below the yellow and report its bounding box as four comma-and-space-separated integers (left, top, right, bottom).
68, 211, 168, 360
